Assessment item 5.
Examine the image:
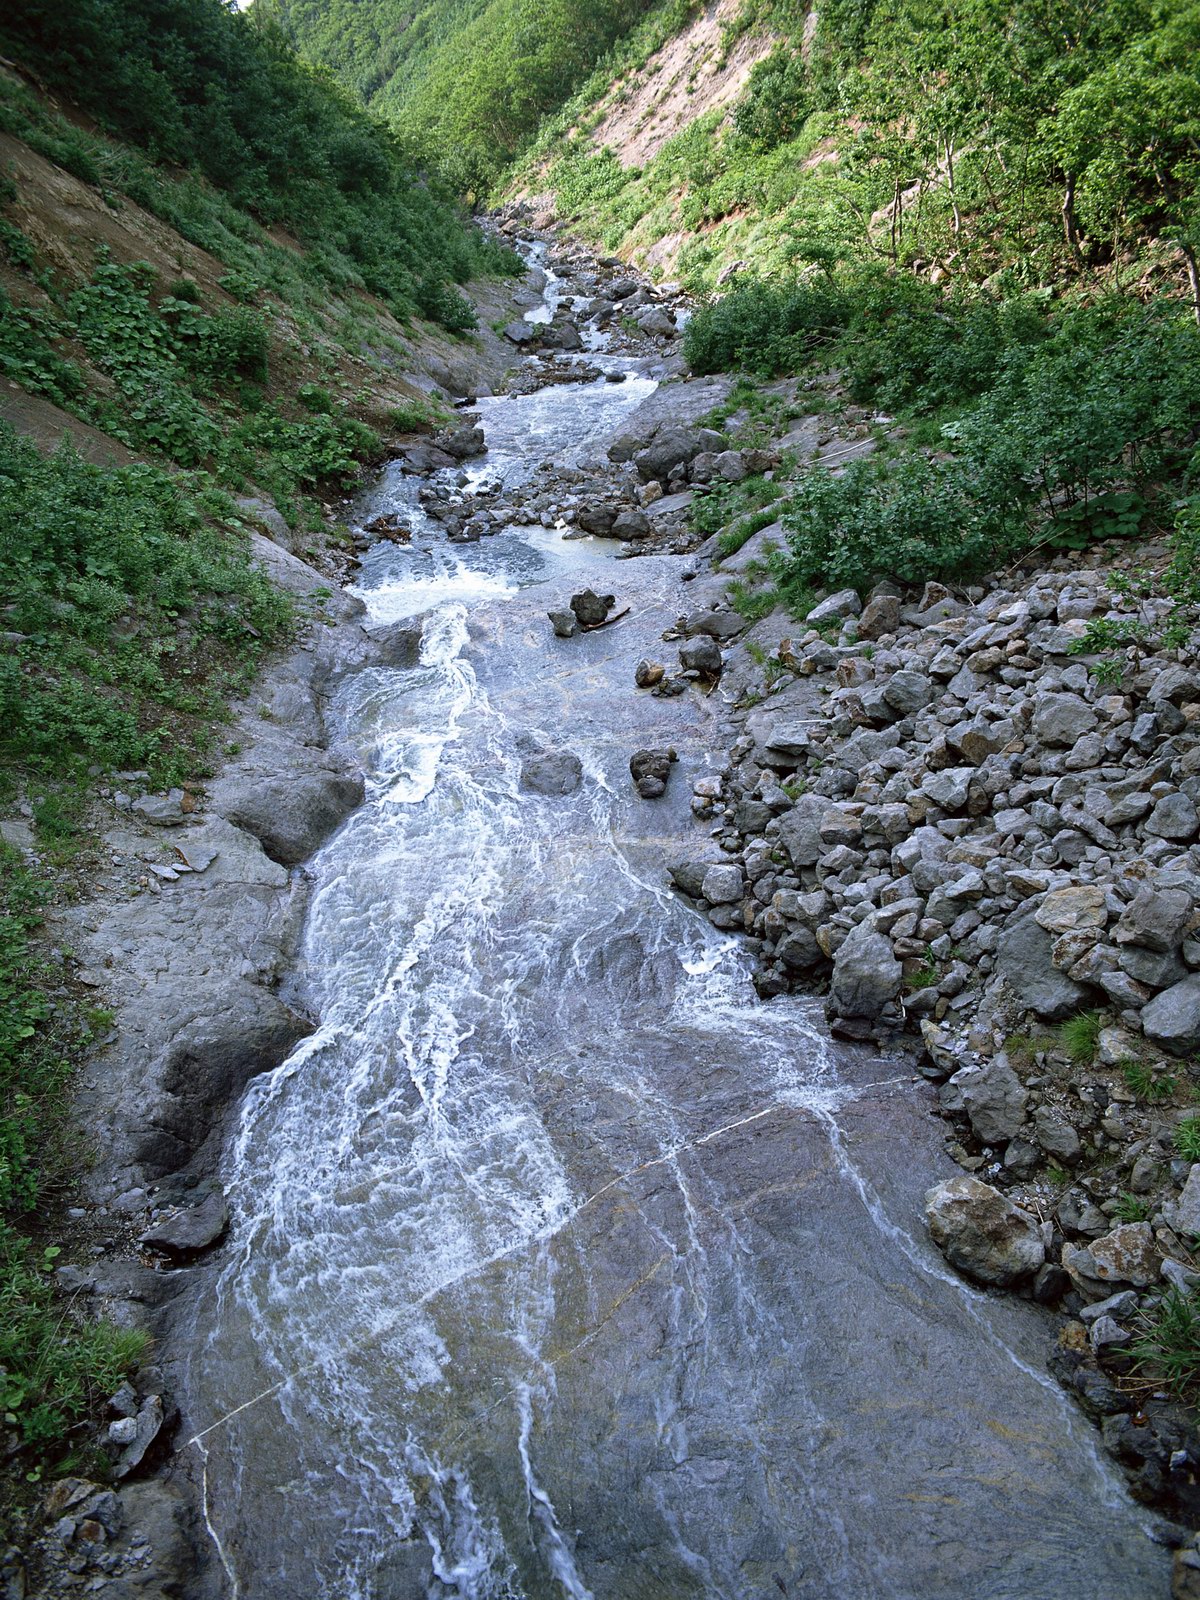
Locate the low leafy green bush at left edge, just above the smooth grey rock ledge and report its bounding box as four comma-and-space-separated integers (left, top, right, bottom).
0, 419, 294, 779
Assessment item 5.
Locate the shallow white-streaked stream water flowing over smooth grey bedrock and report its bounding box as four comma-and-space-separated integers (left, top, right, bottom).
187, 294, 1165, 1600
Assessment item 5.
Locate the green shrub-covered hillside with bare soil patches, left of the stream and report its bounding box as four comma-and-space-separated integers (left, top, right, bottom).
0, 0, 517, 1512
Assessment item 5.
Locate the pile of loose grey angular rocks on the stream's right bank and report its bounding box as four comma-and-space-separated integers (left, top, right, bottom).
672, 557, 1200, 1515
